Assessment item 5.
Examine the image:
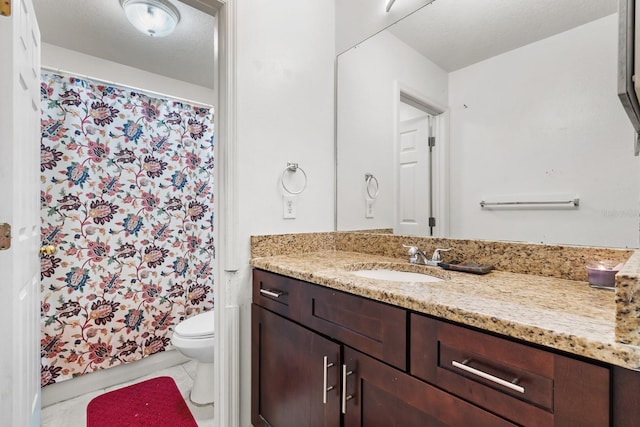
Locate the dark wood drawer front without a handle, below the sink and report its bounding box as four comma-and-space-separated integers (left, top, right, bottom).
300, 284, 407, 370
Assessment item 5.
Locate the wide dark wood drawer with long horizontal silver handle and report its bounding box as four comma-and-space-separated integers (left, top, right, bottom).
410, 314, 609, 426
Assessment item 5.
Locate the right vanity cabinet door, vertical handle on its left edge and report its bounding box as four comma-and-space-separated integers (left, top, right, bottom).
342, 347, 515, 427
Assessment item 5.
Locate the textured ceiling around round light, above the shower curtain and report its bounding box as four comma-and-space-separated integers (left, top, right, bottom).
33, 0, 215, 88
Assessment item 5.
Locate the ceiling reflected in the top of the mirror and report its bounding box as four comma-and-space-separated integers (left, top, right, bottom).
389, 0, 618, 71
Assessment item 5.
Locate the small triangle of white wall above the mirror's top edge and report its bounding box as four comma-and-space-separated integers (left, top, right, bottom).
335, 0, 433, 54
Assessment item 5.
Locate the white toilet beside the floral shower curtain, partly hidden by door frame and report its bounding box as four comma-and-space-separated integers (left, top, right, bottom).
171, 310, 214, 405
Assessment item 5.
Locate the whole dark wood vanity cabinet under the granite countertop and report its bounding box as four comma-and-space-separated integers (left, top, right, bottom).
252, 270, 640, 427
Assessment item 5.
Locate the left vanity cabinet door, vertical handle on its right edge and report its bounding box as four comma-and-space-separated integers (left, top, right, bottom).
251, 304, 340, 427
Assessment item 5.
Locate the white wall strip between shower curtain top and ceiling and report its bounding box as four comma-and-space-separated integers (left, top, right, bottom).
42, 43, 216, 105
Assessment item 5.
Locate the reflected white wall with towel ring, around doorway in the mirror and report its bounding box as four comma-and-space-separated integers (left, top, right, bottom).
337, 31, 448, 230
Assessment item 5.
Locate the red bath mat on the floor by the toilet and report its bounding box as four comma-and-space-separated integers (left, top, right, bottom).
87, 377, 198, 427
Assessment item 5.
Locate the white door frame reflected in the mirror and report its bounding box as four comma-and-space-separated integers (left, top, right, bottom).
392, 80, 450, 237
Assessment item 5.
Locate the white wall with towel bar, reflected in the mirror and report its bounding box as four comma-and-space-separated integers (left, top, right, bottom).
449, 15, 640, 247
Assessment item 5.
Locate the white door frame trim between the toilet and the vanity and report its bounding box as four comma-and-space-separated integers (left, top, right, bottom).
212, 0, 240, 427
